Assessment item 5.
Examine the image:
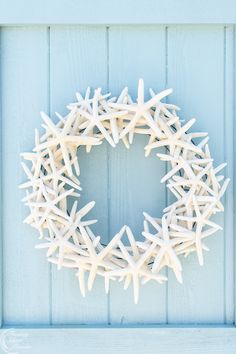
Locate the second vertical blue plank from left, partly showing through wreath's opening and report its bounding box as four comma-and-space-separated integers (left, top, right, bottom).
50, 26, 107, 324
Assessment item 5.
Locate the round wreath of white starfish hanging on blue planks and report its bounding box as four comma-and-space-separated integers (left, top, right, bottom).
20, 79, 229, 303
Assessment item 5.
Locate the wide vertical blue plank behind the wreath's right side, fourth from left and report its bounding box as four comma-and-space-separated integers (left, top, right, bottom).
168, 26, 227, 323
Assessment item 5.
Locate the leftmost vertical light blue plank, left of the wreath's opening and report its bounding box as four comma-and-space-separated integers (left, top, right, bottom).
1, 27, 49, 324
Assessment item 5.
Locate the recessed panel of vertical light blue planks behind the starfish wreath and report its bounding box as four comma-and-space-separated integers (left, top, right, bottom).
1, 26, 234, 330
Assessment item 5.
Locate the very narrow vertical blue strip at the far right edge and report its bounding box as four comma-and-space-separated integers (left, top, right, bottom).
224, 26, 235, 324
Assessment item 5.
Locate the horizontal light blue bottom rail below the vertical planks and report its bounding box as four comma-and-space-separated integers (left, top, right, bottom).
0, 327, 236, 354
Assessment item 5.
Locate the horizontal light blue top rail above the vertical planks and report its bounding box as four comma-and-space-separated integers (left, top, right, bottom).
0, 0, 236, 24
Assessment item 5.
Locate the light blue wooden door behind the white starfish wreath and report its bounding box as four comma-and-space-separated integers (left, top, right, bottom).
0, 0, 236, 354
